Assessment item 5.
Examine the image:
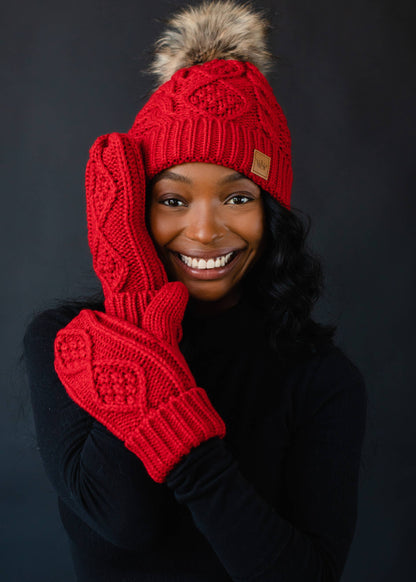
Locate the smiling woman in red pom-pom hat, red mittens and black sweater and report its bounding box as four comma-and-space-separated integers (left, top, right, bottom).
25, 2, 366, 582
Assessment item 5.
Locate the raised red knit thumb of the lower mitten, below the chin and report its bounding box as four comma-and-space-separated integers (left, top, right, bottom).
142, 281, 189, 345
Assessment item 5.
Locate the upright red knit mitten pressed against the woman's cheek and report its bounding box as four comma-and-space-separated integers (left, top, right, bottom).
86, 133, 168, 325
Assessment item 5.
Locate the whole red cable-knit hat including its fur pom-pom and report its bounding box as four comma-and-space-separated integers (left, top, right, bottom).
129, 1, 293, 207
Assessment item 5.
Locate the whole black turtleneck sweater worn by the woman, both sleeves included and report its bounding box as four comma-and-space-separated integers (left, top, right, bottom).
25, 303, 367, 582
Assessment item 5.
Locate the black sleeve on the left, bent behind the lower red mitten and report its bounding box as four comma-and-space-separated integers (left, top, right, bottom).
24, 310, 174, 550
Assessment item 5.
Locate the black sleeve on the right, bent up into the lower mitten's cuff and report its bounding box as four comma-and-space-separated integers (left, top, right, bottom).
167, 350, 367, 582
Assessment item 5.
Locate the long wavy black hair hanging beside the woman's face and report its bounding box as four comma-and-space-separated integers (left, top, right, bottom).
245, 192, 336, 361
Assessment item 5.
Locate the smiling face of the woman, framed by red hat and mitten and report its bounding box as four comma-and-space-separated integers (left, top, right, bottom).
149, 163, 264, 306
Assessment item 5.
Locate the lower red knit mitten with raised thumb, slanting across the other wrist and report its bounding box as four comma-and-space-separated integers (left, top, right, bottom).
55, 282, 225, 483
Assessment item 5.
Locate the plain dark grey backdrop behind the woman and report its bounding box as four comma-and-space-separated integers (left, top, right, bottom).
0, 0, 416, 582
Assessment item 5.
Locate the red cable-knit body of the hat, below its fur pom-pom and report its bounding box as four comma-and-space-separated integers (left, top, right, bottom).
129, 3, 293, 207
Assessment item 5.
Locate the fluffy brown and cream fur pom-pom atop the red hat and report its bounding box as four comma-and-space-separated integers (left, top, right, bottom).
149, 0, 273, 86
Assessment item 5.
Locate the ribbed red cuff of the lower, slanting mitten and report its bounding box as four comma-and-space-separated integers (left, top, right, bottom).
125, 387, 226, 483
